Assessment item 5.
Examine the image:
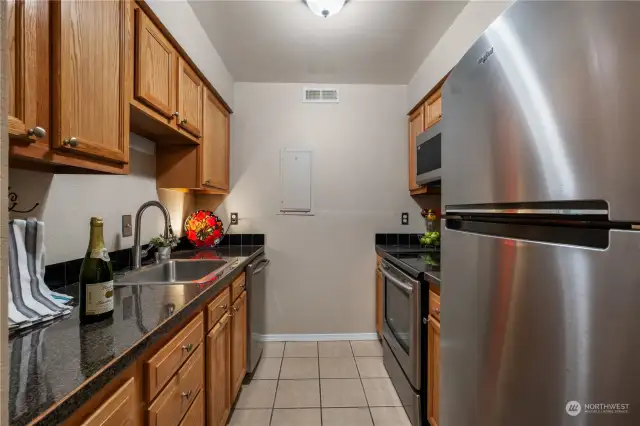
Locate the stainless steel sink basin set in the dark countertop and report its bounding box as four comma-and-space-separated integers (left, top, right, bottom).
115, 259, 235, 285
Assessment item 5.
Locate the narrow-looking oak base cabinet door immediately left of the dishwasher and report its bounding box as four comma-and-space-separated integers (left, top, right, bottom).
231, 291, 247, 401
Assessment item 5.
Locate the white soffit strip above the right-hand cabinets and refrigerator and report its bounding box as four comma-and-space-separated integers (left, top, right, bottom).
405, 0, 513, 111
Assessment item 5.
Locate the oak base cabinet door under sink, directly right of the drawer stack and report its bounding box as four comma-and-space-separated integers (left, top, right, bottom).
207, 314, 231, 426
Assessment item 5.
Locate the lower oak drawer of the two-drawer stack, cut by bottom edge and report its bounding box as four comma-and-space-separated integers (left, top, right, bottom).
149, 346, 204, 426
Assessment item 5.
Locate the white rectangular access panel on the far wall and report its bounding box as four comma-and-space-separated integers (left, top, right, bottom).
280, 149, 311, 214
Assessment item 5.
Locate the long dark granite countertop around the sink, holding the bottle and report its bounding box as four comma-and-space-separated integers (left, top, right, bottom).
9, 246, 264, 425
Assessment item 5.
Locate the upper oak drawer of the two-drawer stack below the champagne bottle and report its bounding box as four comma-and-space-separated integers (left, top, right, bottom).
146, 313, 204, 401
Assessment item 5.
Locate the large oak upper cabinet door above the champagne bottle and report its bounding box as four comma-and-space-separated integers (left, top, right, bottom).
50, 0, 131, 163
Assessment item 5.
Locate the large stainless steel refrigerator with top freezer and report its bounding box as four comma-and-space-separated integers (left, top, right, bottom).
439, 1, 640, 426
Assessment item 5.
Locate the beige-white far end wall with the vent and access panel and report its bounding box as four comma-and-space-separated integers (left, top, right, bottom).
217, 83, 424, 334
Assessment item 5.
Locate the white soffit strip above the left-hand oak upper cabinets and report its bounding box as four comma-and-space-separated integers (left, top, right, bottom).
147, 0, 233, 108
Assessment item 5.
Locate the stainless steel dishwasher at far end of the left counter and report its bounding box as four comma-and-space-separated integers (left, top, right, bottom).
246, 254, 271, 374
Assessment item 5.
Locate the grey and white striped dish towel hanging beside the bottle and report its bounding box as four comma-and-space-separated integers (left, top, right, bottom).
9, 219, 72, 330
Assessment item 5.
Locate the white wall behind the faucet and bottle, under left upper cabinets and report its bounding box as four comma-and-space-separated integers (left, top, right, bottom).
9, 133, 190, 264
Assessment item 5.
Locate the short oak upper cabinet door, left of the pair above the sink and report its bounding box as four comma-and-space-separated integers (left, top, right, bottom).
134, 9, 177, 118
